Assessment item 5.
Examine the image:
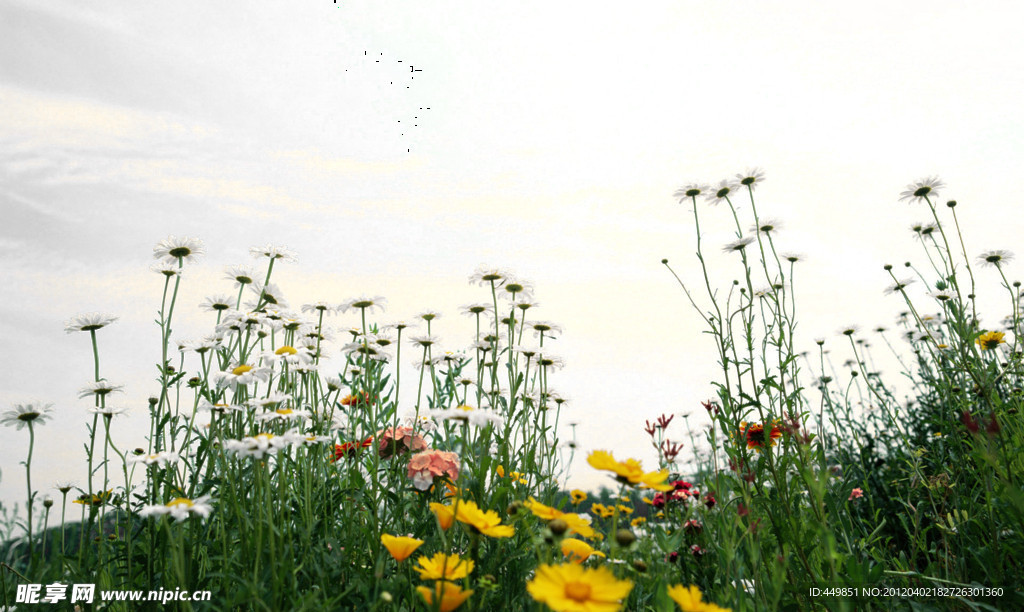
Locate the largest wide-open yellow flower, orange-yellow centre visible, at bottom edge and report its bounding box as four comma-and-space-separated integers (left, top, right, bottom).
526, 563, 633, 612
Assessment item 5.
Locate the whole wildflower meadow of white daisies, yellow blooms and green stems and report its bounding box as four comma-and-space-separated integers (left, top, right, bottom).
0, 170, 1024, 612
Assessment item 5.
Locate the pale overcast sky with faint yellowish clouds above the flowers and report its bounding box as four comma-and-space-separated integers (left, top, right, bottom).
0, 0, 1024, 515
